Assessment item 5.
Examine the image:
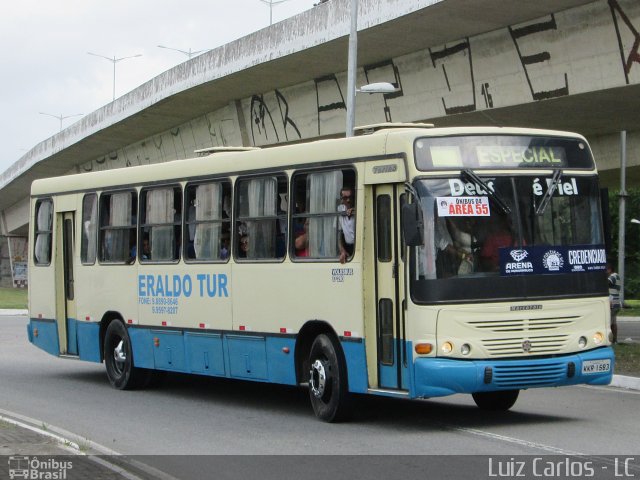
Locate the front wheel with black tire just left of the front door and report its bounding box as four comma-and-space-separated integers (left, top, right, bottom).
309, 334, 351, 422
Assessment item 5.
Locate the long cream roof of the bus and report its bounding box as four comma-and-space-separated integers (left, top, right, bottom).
31, 124, 586, 196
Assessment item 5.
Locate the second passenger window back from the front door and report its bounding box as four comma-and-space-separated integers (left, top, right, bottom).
235, 175, 288, 260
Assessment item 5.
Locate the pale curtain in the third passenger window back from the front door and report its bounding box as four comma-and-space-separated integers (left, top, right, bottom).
194, 183, 222, 260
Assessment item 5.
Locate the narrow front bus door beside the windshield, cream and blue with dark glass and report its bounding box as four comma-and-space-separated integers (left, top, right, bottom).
373, 184, 407, 390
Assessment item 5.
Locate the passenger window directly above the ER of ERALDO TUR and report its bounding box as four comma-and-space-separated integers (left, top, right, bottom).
139, 187, 182, 263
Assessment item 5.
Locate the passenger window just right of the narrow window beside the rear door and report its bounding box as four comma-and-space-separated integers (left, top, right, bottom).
99, 192, 138, 263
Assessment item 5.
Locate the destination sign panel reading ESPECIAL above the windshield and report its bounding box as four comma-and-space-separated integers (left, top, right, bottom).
415, 135, 593, 171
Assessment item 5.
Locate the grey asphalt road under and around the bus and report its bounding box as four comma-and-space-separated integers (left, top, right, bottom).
0, 317, 640, 478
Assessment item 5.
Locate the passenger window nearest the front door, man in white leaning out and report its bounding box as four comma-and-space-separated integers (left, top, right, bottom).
291, 169, 356, 262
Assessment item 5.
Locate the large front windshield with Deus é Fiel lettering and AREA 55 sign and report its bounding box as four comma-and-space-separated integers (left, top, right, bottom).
410, 173, 606, 303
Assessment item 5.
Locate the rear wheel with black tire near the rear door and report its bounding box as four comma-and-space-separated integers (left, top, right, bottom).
104, 320, 152, 390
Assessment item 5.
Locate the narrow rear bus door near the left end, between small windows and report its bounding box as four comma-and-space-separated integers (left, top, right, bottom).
56, 212, 78, 355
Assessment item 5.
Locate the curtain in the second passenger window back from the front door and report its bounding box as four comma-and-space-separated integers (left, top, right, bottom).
247, 178, 278, 258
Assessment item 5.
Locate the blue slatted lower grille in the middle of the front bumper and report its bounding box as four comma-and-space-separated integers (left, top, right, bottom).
493, 362, 567, 388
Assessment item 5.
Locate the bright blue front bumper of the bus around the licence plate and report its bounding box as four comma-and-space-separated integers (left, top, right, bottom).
411, 347, 614, 398
